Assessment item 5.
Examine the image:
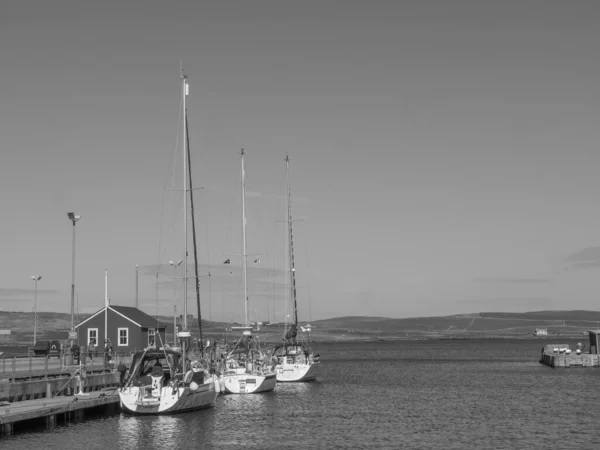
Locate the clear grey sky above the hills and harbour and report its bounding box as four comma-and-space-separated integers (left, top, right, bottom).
0, 0, 600, 322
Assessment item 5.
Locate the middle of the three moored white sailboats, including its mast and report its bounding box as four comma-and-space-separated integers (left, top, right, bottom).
220, 149, 277, 394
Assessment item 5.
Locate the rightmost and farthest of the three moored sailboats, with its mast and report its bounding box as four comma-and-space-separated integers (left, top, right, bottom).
273, 155, 320, 382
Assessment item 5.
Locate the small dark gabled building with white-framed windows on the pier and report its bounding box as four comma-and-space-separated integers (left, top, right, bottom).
75, 305, 167, 353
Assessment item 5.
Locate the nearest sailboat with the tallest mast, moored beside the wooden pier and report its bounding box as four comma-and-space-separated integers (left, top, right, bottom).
119, 71, 218, 414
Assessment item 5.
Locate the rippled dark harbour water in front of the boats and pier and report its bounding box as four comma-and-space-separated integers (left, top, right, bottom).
0, 340, 600, 450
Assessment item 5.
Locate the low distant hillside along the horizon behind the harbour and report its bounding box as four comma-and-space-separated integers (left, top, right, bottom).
0, 311, 600, 345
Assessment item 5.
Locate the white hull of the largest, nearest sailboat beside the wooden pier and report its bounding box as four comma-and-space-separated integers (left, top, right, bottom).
119, 381, 217, 415
